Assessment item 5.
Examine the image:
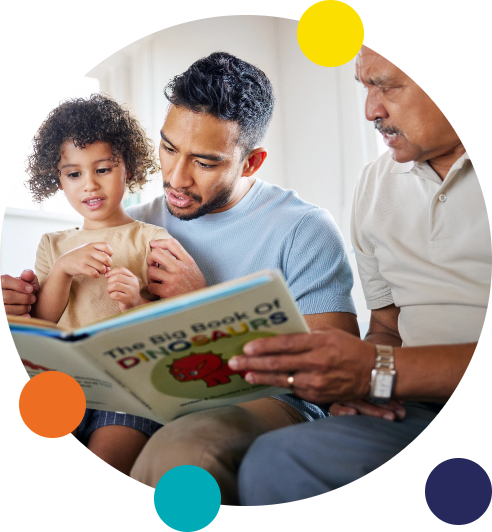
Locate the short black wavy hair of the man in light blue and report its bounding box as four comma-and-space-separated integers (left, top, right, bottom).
164, 52, 275, 159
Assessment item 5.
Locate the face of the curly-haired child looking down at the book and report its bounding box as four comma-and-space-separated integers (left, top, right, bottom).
58, 141, 127, 229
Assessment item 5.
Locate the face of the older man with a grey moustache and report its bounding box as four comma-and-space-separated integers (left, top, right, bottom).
355, 46, 461, 163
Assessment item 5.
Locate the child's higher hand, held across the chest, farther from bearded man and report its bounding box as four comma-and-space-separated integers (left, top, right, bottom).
53, 242, 113, 279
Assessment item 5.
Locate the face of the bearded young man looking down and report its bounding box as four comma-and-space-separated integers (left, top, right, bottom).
159, 105, 243, 220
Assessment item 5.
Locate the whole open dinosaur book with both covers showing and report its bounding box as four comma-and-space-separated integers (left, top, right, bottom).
7, 270, 309, 423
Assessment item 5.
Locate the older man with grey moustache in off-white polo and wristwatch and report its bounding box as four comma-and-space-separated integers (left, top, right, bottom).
229, 46, 492, 505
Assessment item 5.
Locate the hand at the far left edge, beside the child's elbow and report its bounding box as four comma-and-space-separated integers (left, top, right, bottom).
0, 270, 39, 318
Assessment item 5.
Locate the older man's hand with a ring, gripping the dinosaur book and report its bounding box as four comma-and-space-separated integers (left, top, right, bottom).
229, 328, 376, 405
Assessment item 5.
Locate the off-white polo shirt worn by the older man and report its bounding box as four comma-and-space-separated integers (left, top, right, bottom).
351, 151, 492, 346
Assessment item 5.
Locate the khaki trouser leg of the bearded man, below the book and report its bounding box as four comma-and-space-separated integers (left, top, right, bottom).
130, 397, 305, 506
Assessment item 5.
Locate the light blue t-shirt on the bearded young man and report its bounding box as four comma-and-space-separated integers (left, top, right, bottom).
127, 179, 356, 421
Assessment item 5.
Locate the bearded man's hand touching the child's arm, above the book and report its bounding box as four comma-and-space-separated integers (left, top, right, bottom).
147, 238, 207, 299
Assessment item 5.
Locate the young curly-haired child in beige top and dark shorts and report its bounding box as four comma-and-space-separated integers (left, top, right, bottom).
27, 94, 170, 475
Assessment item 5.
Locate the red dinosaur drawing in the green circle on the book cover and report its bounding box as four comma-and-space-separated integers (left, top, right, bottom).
169, 351, 246, 388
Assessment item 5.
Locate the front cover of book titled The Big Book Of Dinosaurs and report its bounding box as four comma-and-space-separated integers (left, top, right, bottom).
76, 277, 309, 422
